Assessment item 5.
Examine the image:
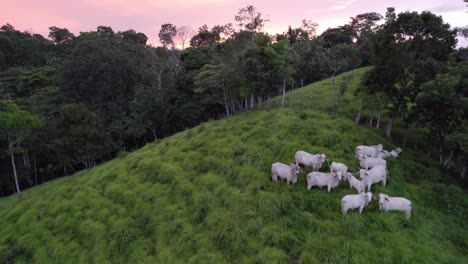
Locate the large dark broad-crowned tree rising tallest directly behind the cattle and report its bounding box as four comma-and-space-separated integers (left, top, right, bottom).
366, 8, 456, 137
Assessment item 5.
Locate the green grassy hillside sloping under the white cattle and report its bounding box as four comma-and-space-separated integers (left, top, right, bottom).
0, 69, 468, 263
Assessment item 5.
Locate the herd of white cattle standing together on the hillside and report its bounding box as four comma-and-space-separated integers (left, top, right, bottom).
271, 144, 411, 219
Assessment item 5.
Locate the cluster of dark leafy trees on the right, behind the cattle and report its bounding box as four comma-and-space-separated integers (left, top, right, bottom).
359, 8, 468, 184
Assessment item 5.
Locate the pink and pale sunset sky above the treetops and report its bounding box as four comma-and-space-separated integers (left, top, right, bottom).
0, 0, 468, 46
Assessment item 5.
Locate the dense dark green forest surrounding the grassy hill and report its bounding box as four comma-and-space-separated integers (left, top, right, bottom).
0, 6, 468, 196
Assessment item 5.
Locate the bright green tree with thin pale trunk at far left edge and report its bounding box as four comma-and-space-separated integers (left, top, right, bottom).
0, 101, 42, 197
